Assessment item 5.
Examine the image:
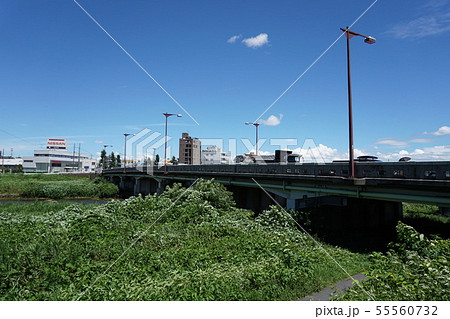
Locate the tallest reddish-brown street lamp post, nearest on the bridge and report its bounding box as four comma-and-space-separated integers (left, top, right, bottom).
340, 27, 376, 178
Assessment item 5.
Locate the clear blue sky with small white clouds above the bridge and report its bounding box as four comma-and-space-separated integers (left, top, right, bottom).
0, 0, 450, 160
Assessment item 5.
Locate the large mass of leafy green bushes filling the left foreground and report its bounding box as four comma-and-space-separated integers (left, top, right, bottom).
0, 182, 367, 300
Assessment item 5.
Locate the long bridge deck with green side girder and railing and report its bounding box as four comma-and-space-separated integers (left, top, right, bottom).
103, 162, 450, 206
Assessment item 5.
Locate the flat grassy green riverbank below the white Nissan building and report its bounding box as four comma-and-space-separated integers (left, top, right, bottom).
0, 174, 119, 199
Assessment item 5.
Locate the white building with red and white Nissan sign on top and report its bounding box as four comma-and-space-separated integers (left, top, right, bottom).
23, 139, 97, 173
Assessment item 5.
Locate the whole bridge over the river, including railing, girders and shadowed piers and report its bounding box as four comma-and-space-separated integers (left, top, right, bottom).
102, 162, 450, 231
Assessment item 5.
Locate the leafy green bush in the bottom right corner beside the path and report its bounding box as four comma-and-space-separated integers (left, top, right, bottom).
338, 222, 450, 300
